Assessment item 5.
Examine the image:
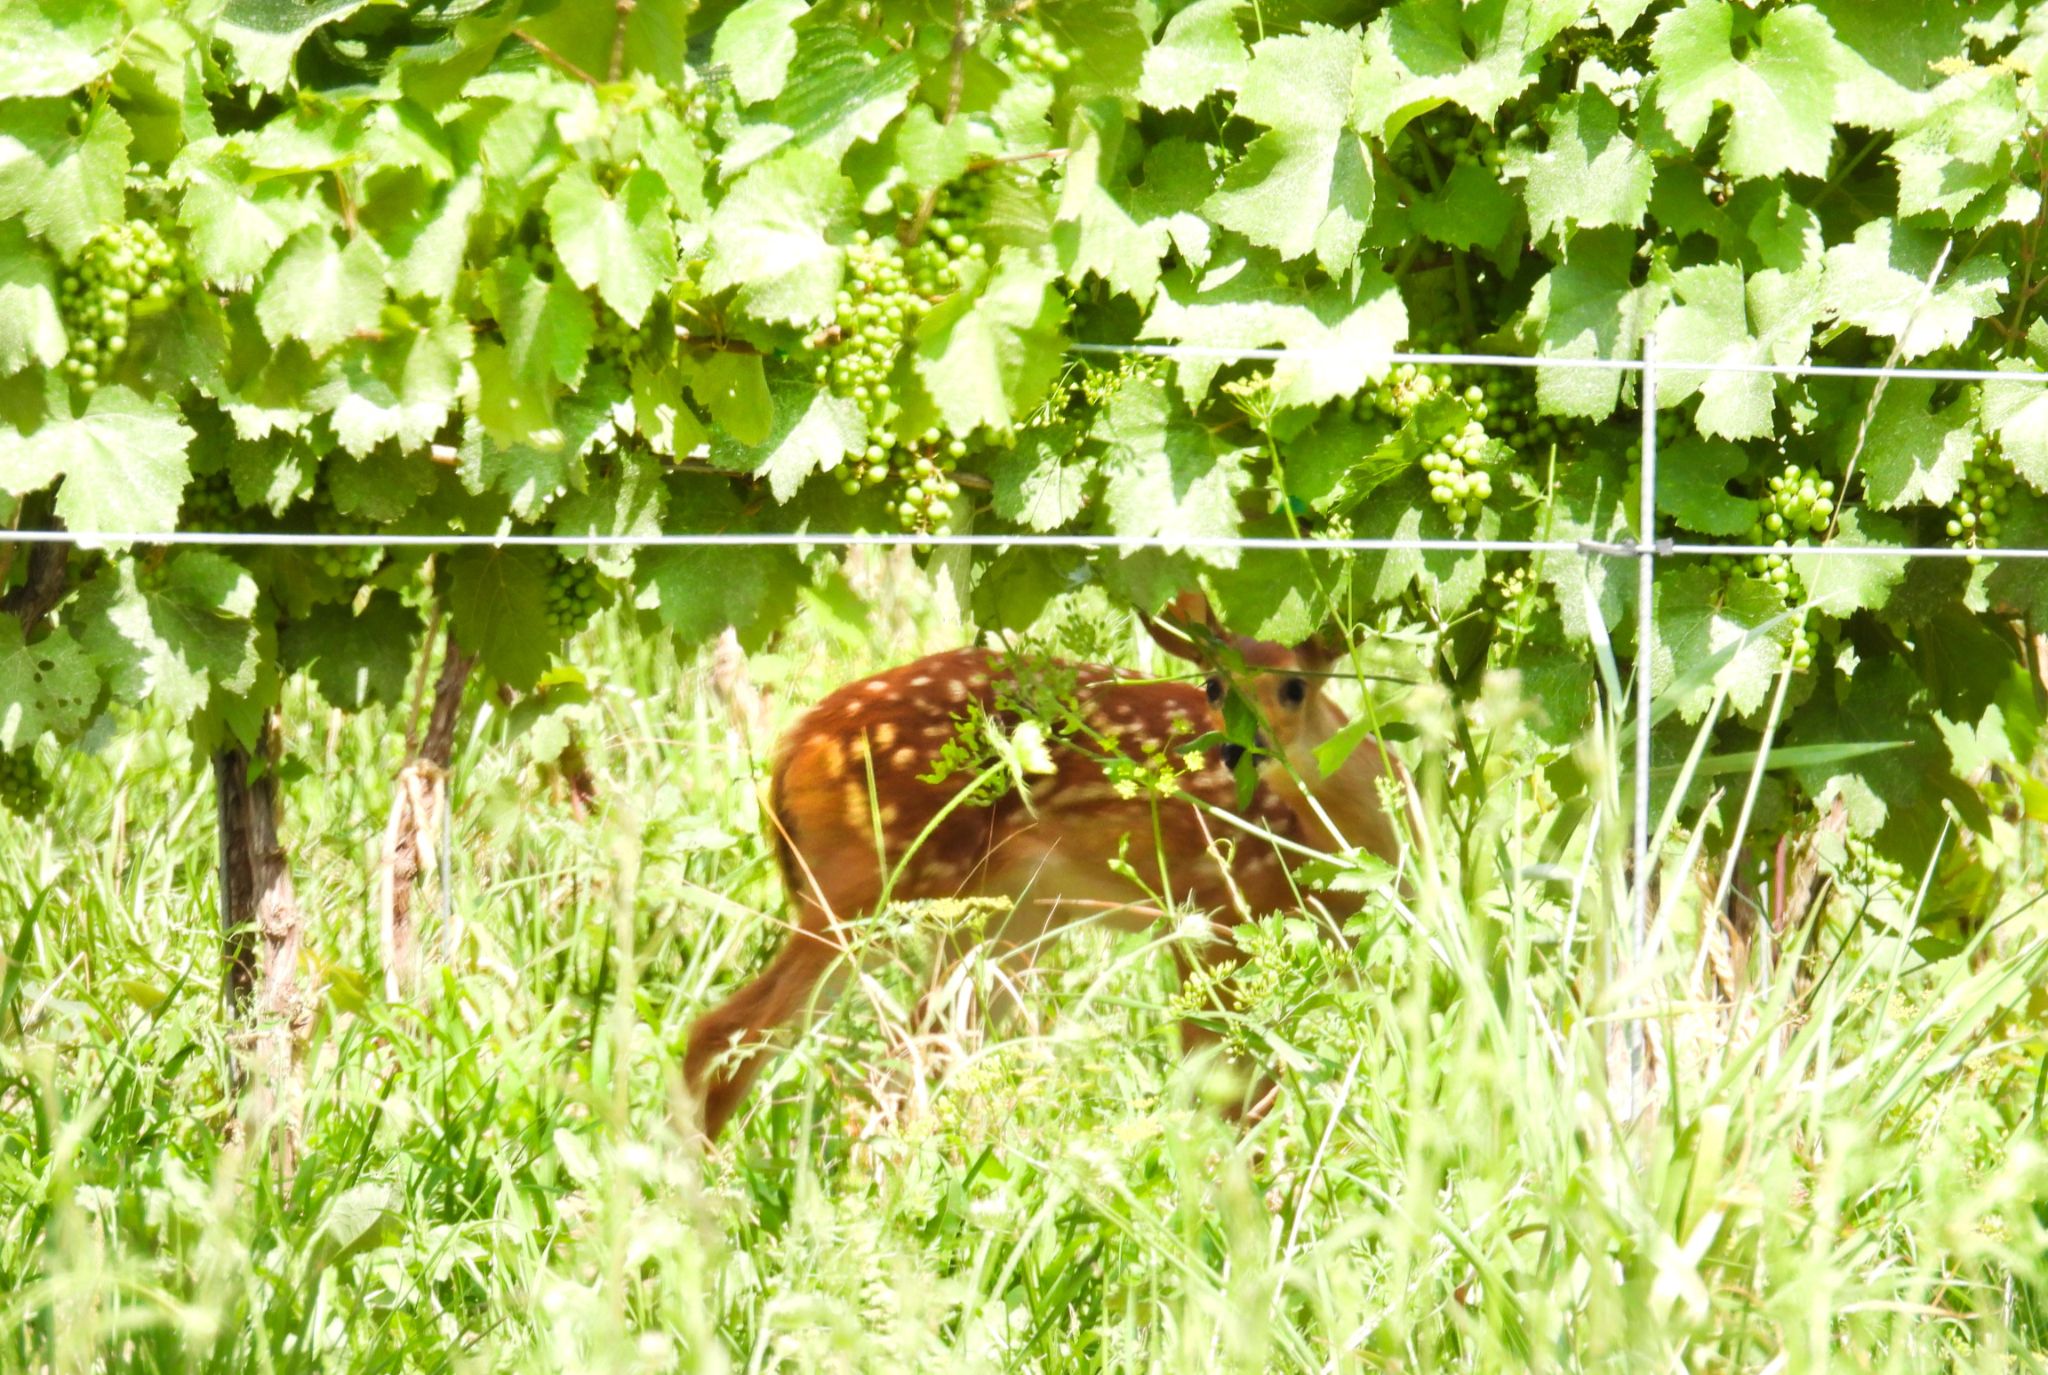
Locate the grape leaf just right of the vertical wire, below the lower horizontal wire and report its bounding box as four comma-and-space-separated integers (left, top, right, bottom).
1651, 568, 1792, 721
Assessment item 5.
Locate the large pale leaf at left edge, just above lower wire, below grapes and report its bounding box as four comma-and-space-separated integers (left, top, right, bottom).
0, 387, 193, 543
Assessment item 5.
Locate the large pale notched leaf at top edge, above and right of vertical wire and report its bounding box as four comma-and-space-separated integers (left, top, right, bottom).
1651, 0, 1839, 178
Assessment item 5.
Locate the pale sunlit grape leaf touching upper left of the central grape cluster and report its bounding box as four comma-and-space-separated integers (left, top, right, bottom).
705, 150, 852, 326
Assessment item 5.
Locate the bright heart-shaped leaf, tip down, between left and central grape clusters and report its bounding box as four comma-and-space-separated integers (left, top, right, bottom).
547, 166, 676, 328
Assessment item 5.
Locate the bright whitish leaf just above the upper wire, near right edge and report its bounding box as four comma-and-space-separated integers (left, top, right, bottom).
1821, 219, 2005, 361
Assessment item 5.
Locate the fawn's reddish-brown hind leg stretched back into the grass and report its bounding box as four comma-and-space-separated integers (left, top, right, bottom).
682, 898, 846, 1141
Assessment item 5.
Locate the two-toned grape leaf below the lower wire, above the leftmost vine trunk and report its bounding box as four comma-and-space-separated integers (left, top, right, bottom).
76, 549, 262, 719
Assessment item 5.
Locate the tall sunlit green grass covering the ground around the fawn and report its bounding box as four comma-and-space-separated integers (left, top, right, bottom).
0, 565, 2048, 1371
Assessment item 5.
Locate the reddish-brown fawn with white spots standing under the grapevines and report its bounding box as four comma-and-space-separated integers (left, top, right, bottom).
684, 596, 1399, 1139
